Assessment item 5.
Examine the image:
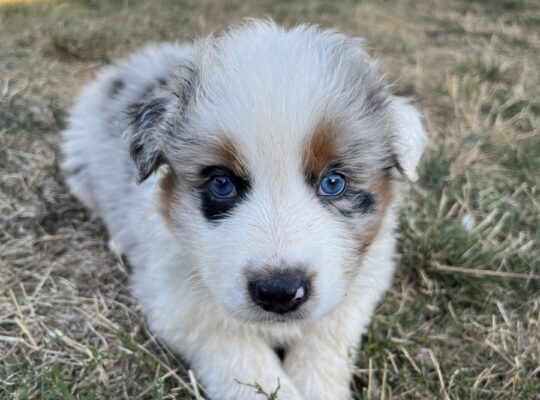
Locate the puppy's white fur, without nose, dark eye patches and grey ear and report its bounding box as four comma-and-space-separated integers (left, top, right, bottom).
63, 22, 425, 400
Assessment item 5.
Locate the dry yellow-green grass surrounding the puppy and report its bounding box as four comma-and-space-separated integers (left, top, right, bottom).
0, 0, 540, 399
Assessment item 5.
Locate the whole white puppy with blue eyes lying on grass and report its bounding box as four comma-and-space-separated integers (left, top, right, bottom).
63, 21, 426, 400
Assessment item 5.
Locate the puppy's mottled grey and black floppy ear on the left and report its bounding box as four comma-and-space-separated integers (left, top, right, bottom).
124, 64, 197, 183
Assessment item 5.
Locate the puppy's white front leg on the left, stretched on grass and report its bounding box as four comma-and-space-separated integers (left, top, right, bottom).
188, 331, 303, 400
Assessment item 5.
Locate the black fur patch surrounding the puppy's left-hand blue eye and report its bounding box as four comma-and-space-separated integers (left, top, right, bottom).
200, 167, 251, 222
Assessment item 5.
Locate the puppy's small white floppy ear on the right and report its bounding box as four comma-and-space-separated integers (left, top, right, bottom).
390, 97, 427, 181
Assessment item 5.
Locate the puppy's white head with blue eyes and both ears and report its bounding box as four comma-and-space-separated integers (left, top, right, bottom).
123, 22, 426, 321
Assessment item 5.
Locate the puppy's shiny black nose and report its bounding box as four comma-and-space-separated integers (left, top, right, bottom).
248, 270, 311, 314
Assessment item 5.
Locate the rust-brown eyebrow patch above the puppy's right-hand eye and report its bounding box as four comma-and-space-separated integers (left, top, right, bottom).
303, 119, 337, 180
